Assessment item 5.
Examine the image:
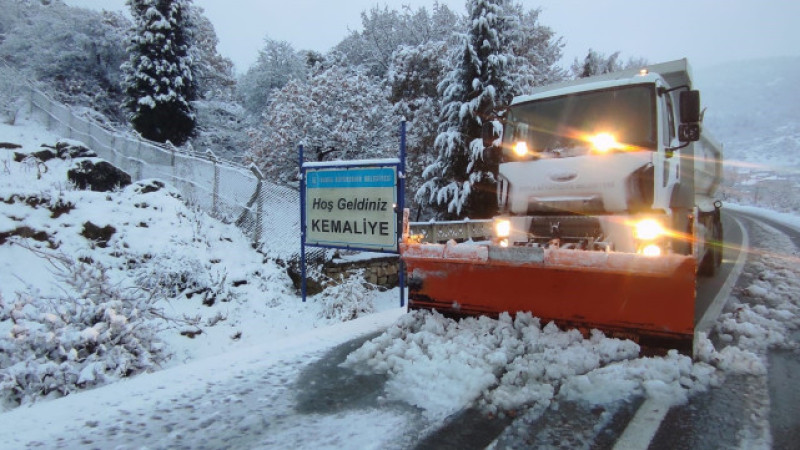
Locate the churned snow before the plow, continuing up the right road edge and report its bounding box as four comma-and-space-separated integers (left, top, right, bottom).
346, 209, 800, 424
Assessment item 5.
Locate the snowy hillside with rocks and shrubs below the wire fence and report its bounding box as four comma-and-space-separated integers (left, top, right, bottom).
0, 119, 398, 412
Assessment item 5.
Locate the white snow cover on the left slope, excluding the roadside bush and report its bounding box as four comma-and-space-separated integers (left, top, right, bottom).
0, 117, 399, 408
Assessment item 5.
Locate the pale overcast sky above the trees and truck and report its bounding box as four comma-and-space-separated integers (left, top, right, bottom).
65, 0, 800, 72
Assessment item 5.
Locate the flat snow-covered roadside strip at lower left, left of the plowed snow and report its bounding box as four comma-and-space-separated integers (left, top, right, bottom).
0, 309, 413, 449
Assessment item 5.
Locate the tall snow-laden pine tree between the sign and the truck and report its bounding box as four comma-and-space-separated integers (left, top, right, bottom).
416, 0, 518, 219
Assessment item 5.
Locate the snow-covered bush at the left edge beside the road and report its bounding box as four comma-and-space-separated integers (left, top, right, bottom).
0, 255, 169, 406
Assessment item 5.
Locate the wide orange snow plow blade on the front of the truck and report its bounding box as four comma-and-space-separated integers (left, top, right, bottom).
401, 243, 695, 355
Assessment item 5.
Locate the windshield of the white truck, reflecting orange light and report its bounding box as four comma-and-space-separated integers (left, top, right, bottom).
504, 84, 657, 157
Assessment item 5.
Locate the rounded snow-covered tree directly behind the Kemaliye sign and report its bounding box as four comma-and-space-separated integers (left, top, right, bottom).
247, 55, 400, 181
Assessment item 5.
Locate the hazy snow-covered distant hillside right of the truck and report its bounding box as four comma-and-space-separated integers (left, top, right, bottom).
695, 57, 800, 212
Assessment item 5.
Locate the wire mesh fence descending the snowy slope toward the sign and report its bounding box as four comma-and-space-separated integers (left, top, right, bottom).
28, 89, 300, 261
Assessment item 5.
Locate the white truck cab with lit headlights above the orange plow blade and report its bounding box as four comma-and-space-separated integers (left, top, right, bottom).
496, 60, 721, 272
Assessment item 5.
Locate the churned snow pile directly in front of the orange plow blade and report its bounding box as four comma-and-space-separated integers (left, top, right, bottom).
345, 311, 716, 419
